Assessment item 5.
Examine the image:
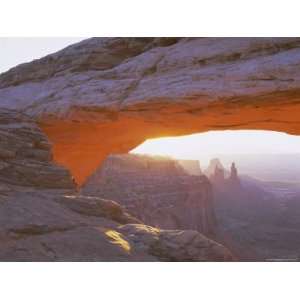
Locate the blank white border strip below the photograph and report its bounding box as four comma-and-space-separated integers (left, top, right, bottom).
0, 263, 299, 300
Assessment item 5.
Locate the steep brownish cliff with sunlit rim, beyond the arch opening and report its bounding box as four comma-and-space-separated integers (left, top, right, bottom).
81, 154, 216, 236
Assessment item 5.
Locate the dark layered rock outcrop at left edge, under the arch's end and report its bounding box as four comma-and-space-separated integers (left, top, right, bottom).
0, 110, 75, 189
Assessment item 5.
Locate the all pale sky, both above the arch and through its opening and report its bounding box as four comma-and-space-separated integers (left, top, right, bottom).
0, 37, 300, 159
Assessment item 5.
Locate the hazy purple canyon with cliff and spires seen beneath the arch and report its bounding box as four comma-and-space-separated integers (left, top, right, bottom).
80, 154, 300, 261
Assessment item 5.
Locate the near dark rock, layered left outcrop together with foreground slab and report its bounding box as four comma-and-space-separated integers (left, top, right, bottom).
0, 109, 232, 261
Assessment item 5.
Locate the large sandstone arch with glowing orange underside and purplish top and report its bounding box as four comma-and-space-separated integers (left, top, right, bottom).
0, 38, 300, 184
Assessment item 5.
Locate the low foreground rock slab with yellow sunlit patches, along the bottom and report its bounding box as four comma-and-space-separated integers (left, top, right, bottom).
0, 190, 234, 261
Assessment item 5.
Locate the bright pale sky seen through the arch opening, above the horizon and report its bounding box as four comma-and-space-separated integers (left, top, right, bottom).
132, 130, 300, 159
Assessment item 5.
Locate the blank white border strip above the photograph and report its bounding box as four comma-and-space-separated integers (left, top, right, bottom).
0, 0, 300, 37
